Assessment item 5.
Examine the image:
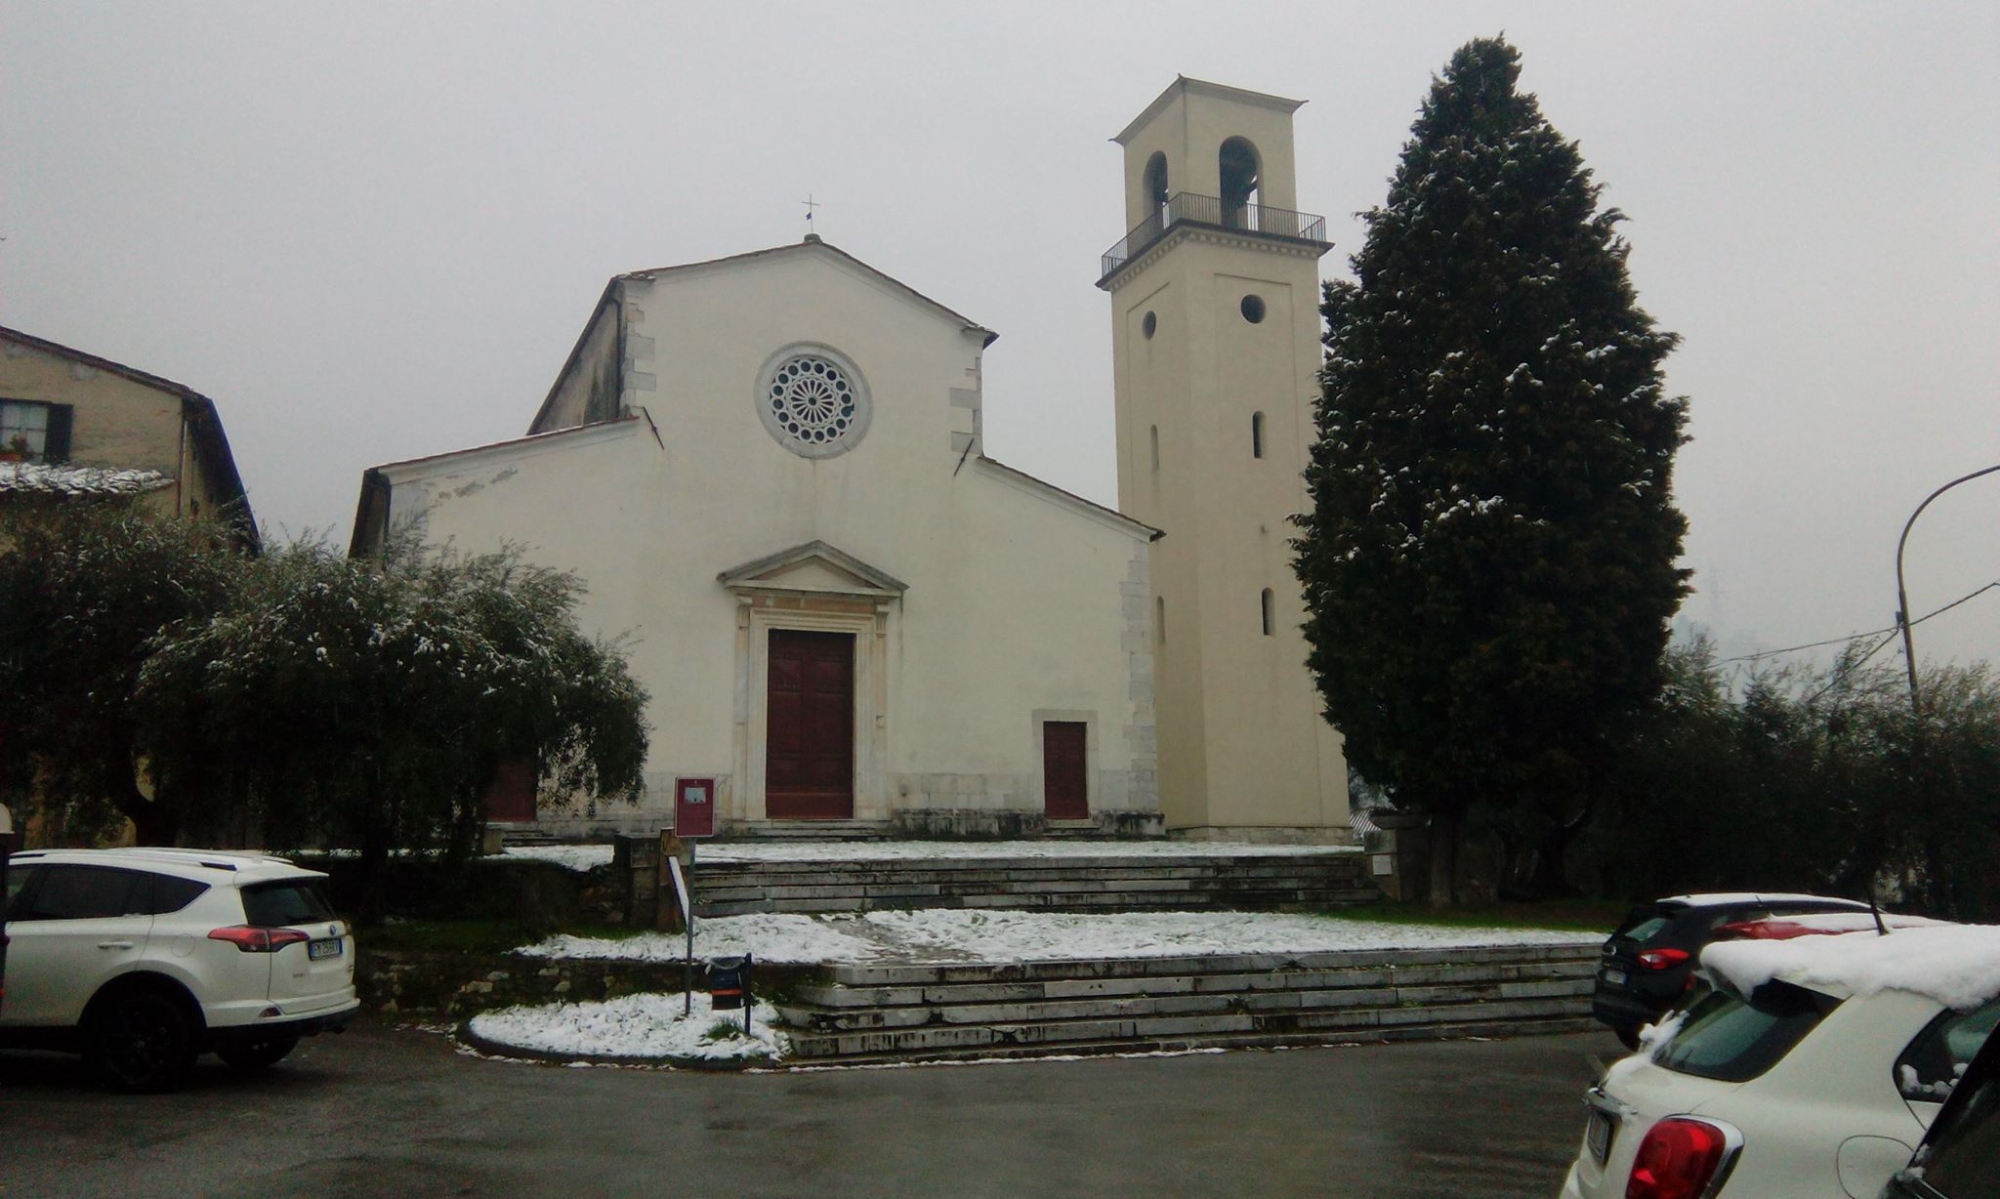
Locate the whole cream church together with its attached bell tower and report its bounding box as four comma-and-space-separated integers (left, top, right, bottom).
354, 78, 1350, 841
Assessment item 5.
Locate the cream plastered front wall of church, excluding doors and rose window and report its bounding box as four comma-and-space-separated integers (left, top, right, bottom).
382, 248, 1158, 825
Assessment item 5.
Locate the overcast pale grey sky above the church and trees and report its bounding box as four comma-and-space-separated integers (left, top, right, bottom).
0, 0, 2000, 661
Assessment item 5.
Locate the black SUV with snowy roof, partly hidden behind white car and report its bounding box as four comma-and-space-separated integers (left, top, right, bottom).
1590, 893, 1868, 1047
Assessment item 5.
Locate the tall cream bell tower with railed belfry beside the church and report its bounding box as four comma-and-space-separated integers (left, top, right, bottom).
1098, 76, 1352, 841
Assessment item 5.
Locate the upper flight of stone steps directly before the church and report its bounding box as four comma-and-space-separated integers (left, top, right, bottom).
694, 853, 1380, 915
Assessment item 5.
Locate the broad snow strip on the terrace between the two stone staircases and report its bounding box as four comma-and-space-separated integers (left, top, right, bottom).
516, 907, 1602, 963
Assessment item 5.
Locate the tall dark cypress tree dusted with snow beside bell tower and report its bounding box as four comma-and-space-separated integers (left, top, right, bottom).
1296, 38, 1688, 903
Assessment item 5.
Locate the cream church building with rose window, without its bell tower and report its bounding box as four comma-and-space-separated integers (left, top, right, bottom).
354, 238, 1160, 835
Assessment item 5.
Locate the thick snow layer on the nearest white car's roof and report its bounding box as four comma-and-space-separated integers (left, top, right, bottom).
1702, 925, 2000, 1011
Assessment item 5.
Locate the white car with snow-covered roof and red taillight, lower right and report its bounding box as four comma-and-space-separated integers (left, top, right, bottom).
1562, 921, 2000, 1199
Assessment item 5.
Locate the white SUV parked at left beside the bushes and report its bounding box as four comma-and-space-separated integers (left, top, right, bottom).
0, 849, 360, 1091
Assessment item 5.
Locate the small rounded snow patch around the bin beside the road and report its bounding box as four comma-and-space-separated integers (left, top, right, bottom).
470, 991, 786, 1061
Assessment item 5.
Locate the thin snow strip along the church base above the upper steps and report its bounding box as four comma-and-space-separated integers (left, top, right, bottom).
500, 841, 1360, 869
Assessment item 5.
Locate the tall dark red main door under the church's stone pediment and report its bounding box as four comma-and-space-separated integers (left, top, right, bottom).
764, 629, 854, 819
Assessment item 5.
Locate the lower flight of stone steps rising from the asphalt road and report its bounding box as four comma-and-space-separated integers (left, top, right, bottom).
780, 945, 1598, 1063
